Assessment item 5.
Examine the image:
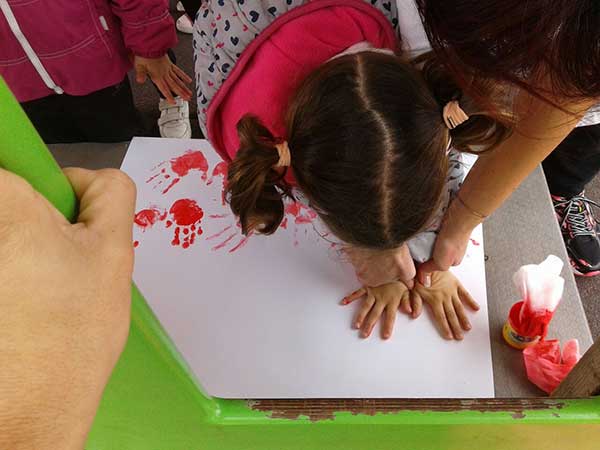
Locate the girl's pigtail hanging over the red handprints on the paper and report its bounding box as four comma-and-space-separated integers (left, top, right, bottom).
226, 115, 292, 234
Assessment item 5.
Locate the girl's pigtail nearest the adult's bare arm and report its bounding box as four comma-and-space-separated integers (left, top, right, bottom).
413, 53, 514, 153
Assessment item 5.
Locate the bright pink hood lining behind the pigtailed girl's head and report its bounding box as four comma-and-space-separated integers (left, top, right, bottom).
207, 0, 398, 182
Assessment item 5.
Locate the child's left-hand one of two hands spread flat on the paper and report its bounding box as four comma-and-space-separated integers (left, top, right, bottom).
342, 281, 410, 339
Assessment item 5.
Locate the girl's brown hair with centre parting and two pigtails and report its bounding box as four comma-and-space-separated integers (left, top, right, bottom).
228, 52, 508, 250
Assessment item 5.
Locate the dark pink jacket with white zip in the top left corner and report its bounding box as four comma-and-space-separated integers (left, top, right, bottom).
0, 0, 177, 102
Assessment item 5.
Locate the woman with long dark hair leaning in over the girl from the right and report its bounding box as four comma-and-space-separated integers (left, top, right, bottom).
355, 0, 600, 285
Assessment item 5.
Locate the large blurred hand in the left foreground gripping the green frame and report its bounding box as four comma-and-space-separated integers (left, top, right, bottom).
0, 169, 135, 450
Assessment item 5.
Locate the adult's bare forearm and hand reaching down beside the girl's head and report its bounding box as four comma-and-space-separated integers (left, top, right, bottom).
419, 93, 597, 284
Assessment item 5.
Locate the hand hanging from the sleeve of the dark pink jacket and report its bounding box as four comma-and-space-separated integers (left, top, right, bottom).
133, 55, 192, 104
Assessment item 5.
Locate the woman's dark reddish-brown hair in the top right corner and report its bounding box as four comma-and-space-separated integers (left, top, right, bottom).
416, 0, 600, 101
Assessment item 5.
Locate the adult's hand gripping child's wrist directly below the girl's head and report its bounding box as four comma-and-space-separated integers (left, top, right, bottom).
346, 245, 416, 289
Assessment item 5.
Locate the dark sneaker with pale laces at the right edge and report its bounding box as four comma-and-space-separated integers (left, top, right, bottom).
552, 192, 600, 277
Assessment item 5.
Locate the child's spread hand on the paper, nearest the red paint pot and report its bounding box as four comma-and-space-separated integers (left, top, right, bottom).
412, 272, 479, 340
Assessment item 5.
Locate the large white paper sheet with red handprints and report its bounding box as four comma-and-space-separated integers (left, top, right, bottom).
123, 138, 494, 398
